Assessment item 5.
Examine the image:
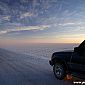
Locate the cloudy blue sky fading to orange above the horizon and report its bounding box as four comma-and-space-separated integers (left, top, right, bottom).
0, 0, 85, 45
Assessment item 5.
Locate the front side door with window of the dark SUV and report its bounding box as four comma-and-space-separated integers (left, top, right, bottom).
71, 44, 85, 72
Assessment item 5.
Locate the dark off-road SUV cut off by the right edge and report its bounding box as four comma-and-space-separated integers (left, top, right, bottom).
49, 40, 85, 80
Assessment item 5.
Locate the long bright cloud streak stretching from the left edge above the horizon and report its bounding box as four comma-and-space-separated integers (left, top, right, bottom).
0, 25, 50, 35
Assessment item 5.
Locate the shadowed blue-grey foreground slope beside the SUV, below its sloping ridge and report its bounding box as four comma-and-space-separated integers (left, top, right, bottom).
0, 49, 73, 85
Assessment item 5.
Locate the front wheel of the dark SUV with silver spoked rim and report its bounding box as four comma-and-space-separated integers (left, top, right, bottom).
53, 63, 66, 80
